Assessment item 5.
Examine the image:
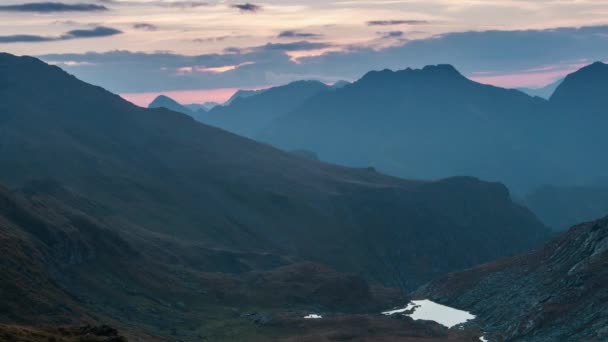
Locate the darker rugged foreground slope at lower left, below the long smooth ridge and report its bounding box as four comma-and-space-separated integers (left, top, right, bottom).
0, 183, 408, 342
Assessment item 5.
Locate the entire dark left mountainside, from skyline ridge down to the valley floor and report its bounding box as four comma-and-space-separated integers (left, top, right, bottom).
0, 54, 550, 341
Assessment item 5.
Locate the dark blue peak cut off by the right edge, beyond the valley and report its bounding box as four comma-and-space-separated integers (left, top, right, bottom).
539, 62, 608, 188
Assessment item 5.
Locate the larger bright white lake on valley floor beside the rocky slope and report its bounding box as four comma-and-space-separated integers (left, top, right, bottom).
382, 299, 475, 328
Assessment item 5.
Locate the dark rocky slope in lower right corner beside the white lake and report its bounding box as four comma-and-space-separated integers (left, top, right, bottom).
418, 218, 608, 341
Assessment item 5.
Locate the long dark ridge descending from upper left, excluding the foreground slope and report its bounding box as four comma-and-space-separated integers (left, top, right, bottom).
0, 54, 547, 314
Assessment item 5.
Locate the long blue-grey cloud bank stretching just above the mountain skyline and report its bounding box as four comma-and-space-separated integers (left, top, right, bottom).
36, 25, 608, 93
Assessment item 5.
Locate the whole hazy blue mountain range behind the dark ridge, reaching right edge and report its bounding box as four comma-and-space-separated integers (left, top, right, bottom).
192, 63, 608, 198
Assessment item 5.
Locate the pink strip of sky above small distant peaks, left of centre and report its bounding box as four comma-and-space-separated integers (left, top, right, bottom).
120, 87, 264, 107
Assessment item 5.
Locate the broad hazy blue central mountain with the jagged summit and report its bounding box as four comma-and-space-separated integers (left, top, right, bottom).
256, 65, 547, 190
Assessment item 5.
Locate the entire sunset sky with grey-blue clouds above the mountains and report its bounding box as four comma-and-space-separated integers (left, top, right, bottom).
0, 0, 608, 104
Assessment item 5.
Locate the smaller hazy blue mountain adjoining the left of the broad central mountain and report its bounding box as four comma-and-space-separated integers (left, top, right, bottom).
198, 81, 330, 138
